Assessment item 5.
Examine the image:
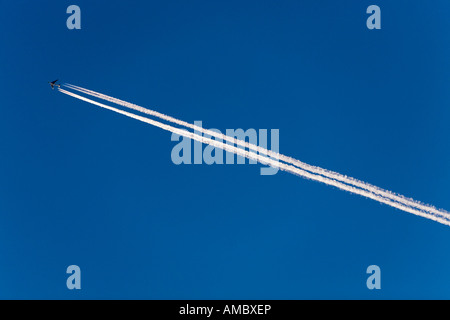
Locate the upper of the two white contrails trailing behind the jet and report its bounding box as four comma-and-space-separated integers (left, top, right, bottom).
64, 83, 450, 218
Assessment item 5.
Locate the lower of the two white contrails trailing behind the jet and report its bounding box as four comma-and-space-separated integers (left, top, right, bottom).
58, 88, 450, 226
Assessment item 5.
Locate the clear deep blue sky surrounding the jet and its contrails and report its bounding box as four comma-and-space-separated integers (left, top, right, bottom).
0, 0, 450, 299
